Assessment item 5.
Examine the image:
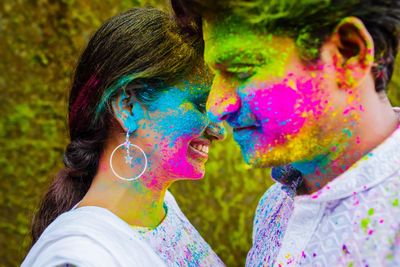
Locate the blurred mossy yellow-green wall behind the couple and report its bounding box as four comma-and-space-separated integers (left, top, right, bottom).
0, 0, 400, 267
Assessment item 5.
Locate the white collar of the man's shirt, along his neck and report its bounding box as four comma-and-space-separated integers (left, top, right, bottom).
295, 108, 400, 202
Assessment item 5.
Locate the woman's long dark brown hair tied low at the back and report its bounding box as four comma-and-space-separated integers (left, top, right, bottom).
31, 8, 204, 244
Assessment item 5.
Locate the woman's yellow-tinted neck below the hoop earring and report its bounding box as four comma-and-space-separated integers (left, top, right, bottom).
79, 162, 170, 228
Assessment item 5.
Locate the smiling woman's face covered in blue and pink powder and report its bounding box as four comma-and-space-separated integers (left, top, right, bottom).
131, 82, 225, 185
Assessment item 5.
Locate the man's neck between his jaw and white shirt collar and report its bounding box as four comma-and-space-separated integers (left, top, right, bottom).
293, 100, 399, 195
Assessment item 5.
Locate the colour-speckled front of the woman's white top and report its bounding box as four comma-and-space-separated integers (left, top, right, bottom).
133, 194, 225, 267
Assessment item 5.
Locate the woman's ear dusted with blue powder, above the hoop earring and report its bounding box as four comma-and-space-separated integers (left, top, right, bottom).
112, 90, 140, 132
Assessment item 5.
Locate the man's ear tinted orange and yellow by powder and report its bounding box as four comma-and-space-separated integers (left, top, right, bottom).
330, 17, 374, 88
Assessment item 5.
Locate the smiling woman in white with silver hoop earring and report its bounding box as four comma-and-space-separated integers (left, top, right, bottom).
22, 9, 224, 267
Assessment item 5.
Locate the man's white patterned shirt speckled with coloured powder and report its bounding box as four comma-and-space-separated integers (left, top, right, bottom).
246, 111, 400, 267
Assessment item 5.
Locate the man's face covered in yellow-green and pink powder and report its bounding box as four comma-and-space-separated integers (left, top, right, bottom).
203, 18, 358, 166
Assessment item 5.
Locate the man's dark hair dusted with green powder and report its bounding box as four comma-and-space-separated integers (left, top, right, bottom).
171, 0, 400, 92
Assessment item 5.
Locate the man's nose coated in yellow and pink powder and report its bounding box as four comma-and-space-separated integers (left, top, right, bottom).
207, 77, 241, 122
